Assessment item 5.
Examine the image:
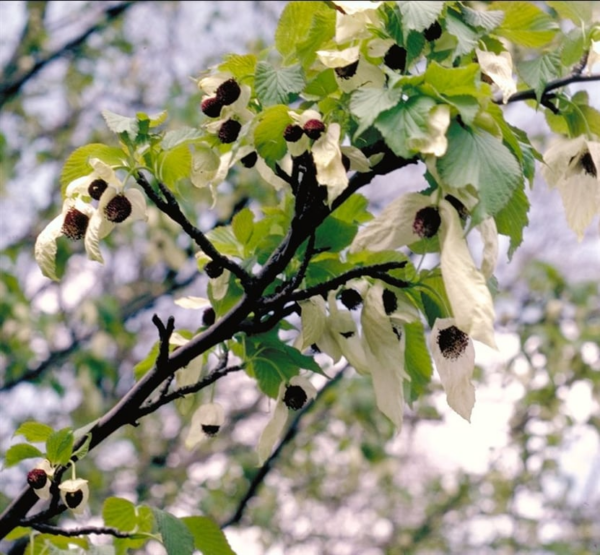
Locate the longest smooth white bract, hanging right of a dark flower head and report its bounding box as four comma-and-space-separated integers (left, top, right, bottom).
439, 200, 496, 349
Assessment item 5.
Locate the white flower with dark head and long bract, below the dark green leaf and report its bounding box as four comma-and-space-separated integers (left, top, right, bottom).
258, 376, 317, 466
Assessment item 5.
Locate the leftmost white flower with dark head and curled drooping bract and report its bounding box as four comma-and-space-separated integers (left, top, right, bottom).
34, 198, 96, 281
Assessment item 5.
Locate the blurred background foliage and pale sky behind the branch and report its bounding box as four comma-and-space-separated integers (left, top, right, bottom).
0, 1, 600, 555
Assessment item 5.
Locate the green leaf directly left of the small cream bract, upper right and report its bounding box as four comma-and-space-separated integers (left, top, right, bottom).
375, 96, 435, 158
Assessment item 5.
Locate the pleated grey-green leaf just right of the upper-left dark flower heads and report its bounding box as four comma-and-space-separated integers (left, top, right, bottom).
254, 62, 305, 106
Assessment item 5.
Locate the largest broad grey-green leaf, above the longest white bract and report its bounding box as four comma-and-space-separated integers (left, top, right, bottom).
437, 122, 523, 216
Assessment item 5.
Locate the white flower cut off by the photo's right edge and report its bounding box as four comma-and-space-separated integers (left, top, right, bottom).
542, 136, 600, 241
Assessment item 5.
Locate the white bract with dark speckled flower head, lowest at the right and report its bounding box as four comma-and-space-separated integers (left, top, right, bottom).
429, 318, 475, 422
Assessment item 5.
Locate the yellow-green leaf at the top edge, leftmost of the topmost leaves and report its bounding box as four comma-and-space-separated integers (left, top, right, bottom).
275, 2, 330, 58
